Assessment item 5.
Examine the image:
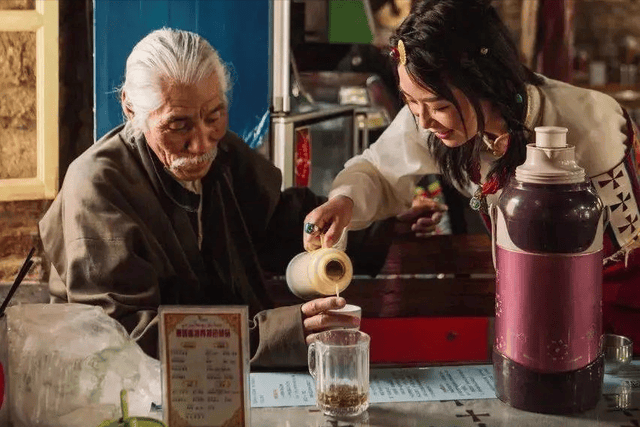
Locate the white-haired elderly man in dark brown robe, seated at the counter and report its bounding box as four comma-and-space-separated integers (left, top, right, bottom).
40, 28, 359, 366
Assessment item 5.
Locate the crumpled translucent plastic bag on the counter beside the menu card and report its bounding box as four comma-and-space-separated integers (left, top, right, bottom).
7, 304, 162, 427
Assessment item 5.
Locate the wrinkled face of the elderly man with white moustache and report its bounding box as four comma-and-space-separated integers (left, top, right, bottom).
144, 73, 227, 181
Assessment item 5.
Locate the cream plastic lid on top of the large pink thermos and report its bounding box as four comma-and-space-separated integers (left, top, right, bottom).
516, 126, 585, 184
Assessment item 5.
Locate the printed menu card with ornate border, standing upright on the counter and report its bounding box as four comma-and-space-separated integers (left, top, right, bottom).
159, 306, 251, 427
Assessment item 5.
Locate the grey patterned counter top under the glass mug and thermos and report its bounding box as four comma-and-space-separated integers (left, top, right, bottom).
251, 361, 640, 427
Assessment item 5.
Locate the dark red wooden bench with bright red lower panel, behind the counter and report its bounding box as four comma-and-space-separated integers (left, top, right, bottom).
268, 234, 495, 364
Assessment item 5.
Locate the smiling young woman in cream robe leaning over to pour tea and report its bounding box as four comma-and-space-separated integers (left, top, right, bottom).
304, 0, 640, 352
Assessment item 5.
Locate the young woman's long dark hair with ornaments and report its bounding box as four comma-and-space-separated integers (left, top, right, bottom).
391, 0, 542, 184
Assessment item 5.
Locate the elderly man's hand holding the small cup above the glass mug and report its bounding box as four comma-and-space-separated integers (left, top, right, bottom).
301, 297, 360, 345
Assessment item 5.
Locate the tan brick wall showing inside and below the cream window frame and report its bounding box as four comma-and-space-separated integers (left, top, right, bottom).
0, 0, 39, 288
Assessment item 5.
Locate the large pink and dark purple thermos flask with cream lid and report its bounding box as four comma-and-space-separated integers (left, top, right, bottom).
490, 126, 606, 414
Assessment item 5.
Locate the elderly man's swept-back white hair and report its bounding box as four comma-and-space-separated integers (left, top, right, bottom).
119, 28, 231, 137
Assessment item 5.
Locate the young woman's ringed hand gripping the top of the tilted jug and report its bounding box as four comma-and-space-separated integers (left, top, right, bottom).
302, 196, 353, 251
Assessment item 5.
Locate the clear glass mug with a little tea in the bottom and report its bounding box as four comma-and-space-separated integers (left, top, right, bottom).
308, 329, 370, 418
